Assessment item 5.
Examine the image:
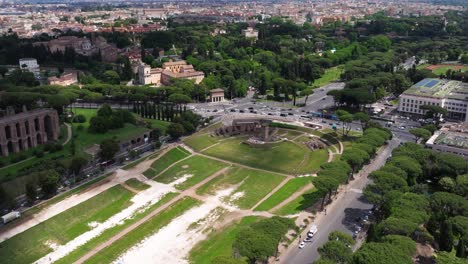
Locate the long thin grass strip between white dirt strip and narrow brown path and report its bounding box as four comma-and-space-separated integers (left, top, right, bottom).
55, 193, 178, 264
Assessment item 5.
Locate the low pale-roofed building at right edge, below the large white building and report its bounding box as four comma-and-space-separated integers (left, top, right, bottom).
426, 123, 468, 160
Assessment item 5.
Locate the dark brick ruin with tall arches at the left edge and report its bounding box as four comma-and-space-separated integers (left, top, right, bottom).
0, 109, 60, 156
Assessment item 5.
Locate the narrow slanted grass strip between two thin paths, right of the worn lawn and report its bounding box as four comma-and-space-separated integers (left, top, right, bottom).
254, 177, 311, 211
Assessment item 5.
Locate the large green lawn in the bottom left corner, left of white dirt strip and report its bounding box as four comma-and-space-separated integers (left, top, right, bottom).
0, 186, 133, 264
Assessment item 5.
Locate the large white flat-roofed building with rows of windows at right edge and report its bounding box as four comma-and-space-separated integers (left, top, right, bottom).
398, 78, 468, 122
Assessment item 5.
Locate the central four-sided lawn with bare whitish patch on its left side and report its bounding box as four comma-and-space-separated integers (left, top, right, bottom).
197, 167, 285, 209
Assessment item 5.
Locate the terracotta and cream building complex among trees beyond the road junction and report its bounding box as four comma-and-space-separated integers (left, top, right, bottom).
138, 60, 205, 86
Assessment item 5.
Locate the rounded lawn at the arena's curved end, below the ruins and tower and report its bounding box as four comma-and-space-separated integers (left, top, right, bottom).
203, 137, 328, 174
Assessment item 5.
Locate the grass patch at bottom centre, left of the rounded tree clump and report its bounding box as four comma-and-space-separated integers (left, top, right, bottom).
189, 216, 261, 264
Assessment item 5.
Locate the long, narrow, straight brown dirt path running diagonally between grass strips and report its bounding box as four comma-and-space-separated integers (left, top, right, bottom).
74, 168, 227, 264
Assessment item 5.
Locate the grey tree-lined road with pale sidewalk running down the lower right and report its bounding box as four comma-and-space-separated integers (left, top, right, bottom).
280, 139, 400, 264
